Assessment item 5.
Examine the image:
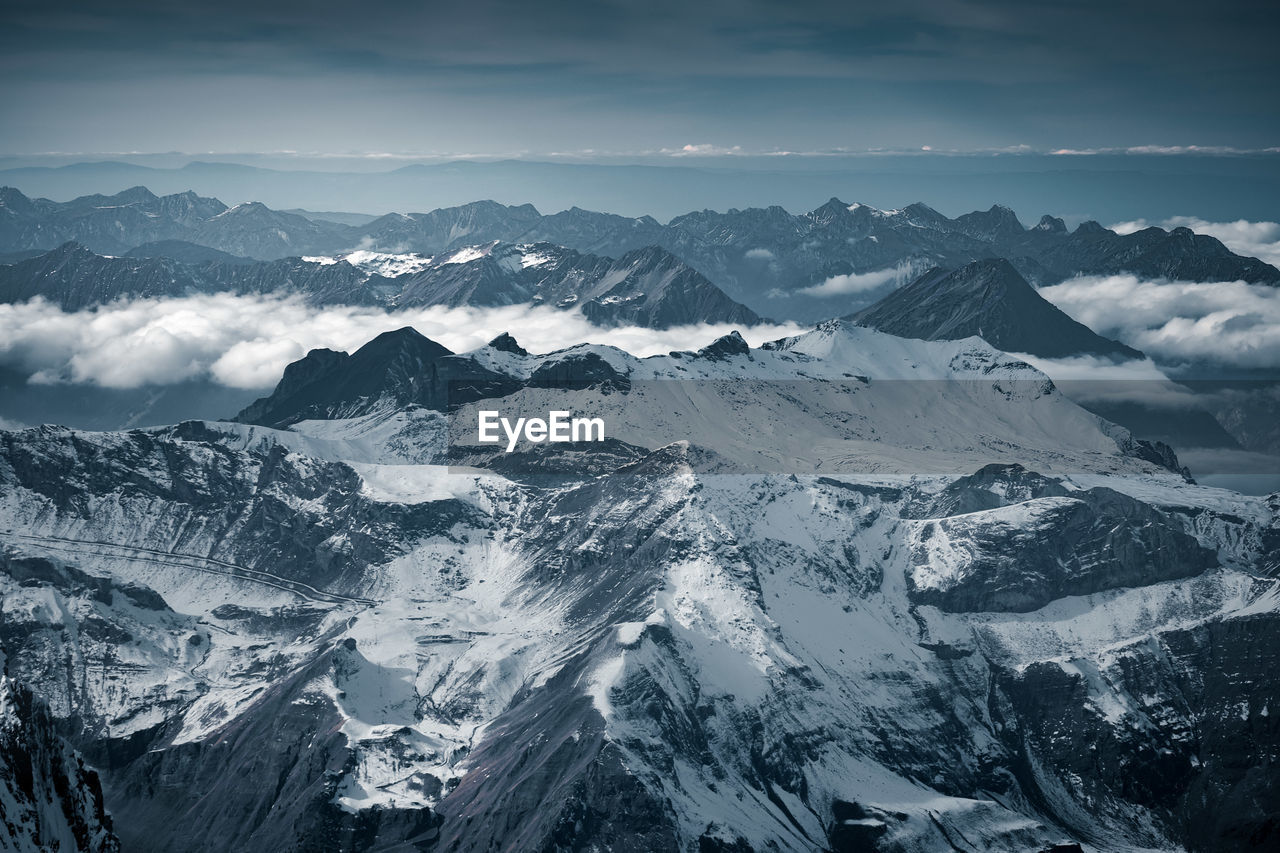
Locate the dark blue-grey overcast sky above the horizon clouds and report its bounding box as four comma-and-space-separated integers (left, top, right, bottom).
0, 0, 1280, 158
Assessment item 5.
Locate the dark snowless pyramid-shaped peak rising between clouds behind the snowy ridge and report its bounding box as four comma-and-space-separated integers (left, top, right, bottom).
849, 253, 1142, 359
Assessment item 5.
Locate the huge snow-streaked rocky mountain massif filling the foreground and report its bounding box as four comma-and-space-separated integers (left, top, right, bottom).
0, 321, 1280, 852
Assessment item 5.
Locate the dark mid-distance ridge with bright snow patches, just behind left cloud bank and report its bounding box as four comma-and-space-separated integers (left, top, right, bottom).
0, 242, 760, 328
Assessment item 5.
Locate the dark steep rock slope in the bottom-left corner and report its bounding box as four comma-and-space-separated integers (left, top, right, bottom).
0, 671, 120, 853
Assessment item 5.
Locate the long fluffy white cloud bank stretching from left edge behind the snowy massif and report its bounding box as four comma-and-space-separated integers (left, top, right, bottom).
0, 293, 801, 388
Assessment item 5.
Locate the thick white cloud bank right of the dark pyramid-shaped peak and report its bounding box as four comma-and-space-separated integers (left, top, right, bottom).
1039, 275, 1280, 368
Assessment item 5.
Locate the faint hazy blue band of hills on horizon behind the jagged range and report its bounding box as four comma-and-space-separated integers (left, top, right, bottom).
0, 152, 1280, 224
